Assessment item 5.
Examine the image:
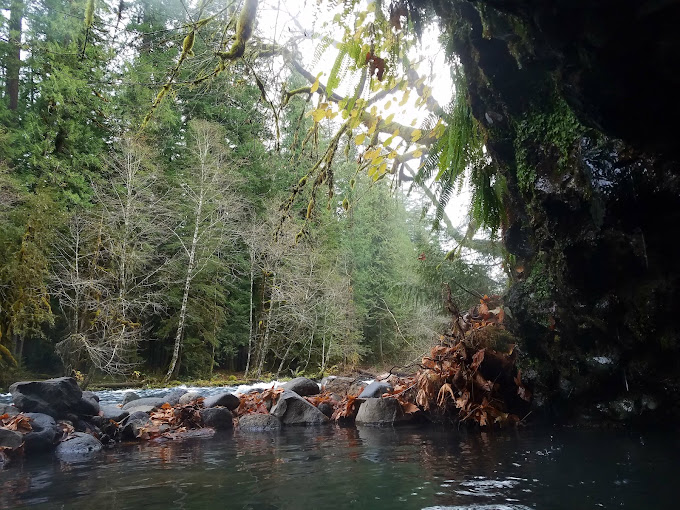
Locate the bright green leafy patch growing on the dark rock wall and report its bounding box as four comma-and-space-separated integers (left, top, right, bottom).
514, 96, 585, 192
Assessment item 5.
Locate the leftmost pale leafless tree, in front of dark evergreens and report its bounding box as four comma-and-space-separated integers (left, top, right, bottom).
52, 138, 165, 374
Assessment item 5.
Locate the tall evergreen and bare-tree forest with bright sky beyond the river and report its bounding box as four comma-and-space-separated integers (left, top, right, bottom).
0, 0, 500, 386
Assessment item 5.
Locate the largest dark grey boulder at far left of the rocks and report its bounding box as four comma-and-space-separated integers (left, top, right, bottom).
9, 377, 83, 418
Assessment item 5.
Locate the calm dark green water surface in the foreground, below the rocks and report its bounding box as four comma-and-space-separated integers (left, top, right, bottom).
0, 426, 680, 510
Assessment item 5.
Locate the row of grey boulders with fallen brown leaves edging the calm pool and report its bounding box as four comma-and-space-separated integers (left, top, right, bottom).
0, 377, 430, 465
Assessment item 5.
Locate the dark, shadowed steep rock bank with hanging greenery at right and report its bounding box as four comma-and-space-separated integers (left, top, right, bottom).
433, 0, 680, 420
